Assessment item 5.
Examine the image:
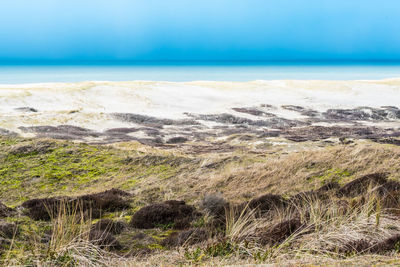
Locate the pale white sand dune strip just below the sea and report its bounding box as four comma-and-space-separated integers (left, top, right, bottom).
0, 79, 400, 147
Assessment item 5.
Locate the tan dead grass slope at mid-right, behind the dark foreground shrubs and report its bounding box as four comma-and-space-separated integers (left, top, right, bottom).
136, 142, 400, 206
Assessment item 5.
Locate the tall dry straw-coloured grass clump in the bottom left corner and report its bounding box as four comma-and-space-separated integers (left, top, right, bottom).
2, 202, 120, 267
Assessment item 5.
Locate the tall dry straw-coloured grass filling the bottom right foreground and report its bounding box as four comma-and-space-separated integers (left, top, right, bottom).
113, 199, 400, 266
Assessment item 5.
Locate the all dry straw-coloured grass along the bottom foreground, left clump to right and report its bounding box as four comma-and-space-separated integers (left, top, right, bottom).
6, 191, 400, 266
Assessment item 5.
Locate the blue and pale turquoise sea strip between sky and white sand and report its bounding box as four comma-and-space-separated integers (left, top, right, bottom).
0, 62, 400, 84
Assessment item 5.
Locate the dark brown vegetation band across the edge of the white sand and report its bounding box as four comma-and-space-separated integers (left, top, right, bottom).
10, 104, 400, 147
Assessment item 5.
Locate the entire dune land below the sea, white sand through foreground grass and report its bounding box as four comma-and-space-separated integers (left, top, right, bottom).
0, 79, 400, 266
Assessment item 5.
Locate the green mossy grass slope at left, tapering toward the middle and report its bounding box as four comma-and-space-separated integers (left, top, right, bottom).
0, 138, 195, 205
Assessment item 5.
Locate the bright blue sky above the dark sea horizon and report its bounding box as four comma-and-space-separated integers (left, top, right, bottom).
0, 0, 400, 62
